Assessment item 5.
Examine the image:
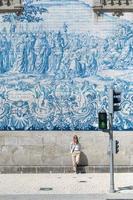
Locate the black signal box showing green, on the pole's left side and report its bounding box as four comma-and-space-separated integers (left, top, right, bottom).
98, 111, 107, 130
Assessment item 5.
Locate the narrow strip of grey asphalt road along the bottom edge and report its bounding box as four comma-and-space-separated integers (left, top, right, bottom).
0, 194, 133, 200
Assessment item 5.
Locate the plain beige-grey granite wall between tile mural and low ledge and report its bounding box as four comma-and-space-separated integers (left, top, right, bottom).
0, 131, 133, 172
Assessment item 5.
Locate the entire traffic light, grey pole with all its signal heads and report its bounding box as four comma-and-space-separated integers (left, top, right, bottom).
98, 85, 121, 193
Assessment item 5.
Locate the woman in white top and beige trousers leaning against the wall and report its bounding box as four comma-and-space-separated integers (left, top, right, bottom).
70, 135, 81, 173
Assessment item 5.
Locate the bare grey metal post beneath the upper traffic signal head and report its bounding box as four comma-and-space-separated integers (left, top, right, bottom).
109, 113, 115, 193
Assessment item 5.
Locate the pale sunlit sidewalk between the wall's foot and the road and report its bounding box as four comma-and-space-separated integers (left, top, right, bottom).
0, 173, 133, 195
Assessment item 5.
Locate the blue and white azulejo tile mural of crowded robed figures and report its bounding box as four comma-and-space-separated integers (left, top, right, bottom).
0, 0, 133, 130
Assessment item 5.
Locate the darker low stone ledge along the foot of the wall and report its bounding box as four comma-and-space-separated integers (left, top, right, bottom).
0, 166, 133, 174
